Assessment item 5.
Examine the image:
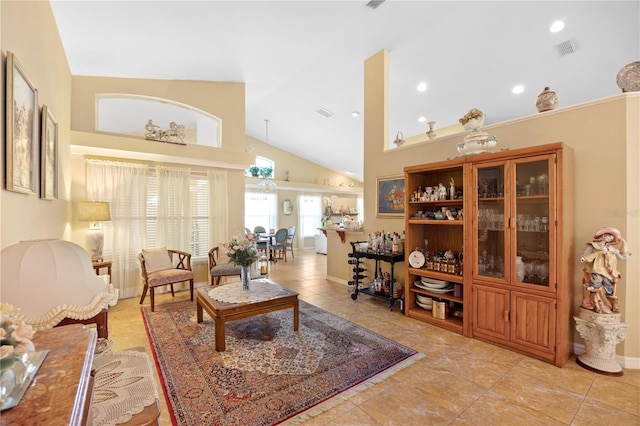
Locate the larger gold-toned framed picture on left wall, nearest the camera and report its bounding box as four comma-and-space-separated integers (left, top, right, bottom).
5, 52, 39, 194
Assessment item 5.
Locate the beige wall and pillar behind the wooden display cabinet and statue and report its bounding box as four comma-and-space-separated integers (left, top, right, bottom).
328, 52, 640, 358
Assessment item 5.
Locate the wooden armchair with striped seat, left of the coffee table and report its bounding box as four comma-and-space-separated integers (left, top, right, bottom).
138, 247, 193, 312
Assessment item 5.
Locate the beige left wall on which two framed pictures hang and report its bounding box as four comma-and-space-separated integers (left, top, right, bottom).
0, 1, 71, 248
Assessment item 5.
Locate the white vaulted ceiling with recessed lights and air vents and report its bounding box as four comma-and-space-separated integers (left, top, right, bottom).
51, 0, 640, 179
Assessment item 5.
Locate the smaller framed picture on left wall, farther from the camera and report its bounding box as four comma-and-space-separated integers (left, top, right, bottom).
40, 105, 58, 200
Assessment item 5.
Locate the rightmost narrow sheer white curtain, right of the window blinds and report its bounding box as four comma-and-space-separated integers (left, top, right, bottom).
207, 170, 229, 247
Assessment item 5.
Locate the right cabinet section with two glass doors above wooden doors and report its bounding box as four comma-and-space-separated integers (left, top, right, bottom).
469, 144, 573, 366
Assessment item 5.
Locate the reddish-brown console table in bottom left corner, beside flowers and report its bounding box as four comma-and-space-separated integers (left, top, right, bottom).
0, 324, 97, 426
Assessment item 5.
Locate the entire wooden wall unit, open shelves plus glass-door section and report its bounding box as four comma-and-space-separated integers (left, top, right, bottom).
404, 143, 573, 366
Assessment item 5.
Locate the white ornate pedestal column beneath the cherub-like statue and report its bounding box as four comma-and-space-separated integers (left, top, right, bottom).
573, 308, 629, 376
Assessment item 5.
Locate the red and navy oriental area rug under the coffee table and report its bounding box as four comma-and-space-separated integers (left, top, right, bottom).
141, 301, 422, 426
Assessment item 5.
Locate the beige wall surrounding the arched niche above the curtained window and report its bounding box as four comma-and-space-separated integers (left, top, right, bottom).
71, 76, 253, 248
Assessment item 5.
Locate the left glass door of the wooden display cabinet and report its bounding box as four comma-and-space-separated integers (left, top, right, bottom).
473, 164, 509, 280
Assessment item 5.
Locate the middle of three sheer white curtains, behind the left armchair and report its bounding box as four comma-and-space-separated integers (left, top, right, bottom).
156, 167, 192, 253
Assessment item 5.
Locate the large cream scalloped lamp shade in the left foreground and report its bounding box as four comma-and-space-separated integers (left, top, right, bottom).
0, 240, 118, 329
